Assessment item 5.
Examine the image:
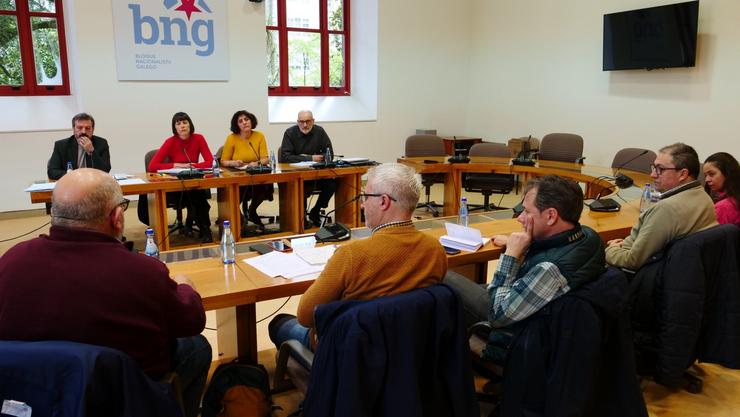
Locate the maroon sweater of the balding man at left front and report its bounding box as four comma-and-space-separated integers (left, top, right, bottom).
0, 226, 206, 378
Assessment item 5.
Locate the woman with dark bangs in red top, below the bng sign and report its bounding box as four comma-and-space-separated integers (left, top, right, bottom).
147, 112, 213, 243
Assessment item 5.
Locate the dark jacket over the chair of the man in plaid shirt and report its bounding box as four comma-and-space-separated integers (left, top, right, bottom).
500, 267, 648, 417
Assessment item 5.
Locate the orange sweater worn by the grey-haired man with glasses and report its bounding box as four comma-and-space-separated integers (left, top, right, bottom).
297, 226, 447, 327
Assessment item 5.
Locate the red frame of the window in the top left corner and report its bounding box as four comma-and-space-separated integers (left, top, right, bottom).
0, 0, 70, 96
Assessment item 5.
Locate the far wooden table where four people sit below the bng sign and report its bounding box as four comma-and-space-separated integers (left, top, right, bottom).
30, 164, 368, 250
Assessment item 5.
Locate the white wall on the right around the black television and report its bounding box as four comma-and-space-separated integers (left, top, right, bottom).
467, 0, 740, 165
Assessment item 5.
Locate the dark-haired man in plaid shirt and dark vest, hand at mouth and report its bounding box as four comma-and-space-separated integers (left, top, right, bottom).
444, 175, 605, 327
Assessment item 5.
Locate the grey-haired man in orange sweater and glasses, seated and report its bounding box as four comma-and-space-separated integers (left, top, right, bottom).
269, 164, 447, 347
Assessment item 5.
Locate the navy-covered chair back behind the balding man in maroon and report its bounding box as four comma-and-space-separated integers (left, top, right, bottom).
0, 341, 182, 416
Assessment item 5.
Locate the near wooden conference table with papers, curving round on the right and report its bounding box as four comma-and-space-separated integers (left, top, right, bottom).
162, 158, 649, 361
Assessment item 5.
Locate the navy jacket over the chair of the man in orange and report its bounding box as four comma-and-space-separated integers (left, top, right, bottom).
303, 285, 480, 417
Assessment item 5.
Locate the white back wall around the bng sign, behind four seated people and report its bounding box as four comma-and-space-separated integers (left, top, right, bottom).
0, 0, 471, 212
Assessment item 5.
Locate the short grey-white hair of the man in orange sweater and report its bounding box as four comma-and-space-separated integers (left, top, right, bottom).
367, 163, 421, 212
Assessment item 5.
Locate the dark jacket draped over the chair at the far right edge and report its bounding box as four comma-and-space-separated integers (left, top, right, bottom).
630, 224, 740, 387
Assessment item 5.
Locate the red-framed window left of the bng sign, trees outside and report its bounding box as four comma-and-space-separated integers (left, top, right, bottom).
0, 0, 69, 96
